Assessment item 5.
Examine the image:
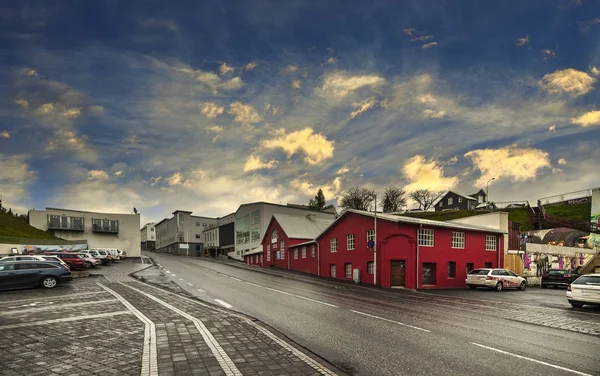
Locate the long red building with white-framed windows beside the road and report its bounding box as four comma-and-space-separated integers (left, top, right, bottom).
272, 210, 504, 289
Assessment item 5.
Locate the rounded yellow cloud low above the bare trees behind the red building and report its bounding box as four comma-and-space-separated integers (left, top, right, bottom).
402, 155, 459, 192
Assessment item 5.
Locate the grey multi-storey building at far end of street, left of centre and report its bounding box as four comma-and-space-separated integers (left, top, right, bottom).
156, 210, 217, 256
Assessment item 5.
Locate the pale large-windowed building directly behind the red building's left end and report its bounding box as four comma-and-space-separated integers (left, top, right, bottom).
228, 202, 336, 261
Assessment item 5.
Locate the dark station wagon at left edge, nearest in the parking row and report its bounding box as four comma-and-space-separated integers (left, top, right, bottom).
0, 261, 73, 290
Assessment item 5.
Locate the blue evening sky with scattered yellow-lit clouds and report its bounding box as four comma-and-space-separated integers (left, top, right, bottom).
0, 0, 600, 223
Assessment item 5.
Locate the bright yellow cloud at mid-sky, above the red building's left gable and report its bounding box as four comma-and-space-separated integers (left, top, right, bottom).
261, 128, 334, 165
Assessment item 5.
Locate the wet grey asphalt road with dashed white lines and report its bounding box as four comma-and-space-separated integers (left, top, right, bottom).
149, 253, 600, 376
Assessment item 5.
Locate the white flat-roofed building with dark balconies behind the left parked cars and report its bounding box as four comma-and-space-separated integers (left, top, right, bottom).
29, 208, 141, 256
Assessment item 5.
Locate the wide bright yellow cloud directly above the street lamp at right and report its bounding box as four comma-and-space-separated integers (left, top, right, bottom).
465, 145, 551, 186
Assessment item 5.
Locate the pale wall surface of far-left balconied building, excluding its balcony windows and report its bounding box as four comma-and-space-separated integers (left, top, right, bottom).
29, 208, 141, 256
